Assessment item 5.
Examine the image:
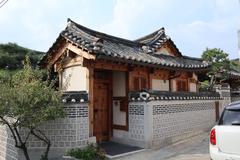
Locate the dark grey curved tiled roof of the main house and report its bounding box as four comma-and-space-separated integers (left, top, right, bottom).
41, 19, 209, 69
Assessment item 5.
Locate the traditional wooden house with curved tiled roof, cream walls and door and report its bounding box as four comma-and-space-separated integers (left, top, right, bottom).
42, 20, 209, 142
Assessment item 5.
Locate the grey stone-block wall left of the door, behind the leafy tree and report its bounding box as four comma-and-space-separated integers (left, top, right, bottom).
0, 102, 89, 160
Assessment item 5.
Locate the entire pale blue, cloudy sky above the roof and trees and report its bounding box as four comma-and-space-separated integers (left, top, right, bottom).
0, 0, 240, 58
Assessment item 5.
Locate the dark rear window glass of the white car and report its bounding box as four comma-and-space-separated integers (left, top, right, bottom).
219, 109, 240, 125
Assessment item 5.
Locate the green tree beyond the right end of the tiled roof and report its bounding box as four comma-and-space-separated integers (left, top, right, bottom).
202, 48, 237, 89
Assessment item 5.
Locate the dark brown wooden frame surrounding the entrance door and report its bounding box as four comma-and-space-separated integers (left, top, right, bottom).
93, 70, 113, 141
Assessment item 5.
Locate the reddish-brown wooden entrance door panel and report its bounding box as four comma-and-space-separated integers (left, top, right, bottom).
93, 81, 109, 142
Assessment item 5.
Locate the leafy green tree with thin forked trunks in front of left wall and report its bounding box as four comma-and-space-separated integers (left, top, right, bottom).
0, 58, 65, 160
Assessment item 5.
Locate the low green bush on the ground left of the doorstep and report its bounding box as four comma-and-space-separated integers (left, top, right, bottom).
66, 144, 106, 160
